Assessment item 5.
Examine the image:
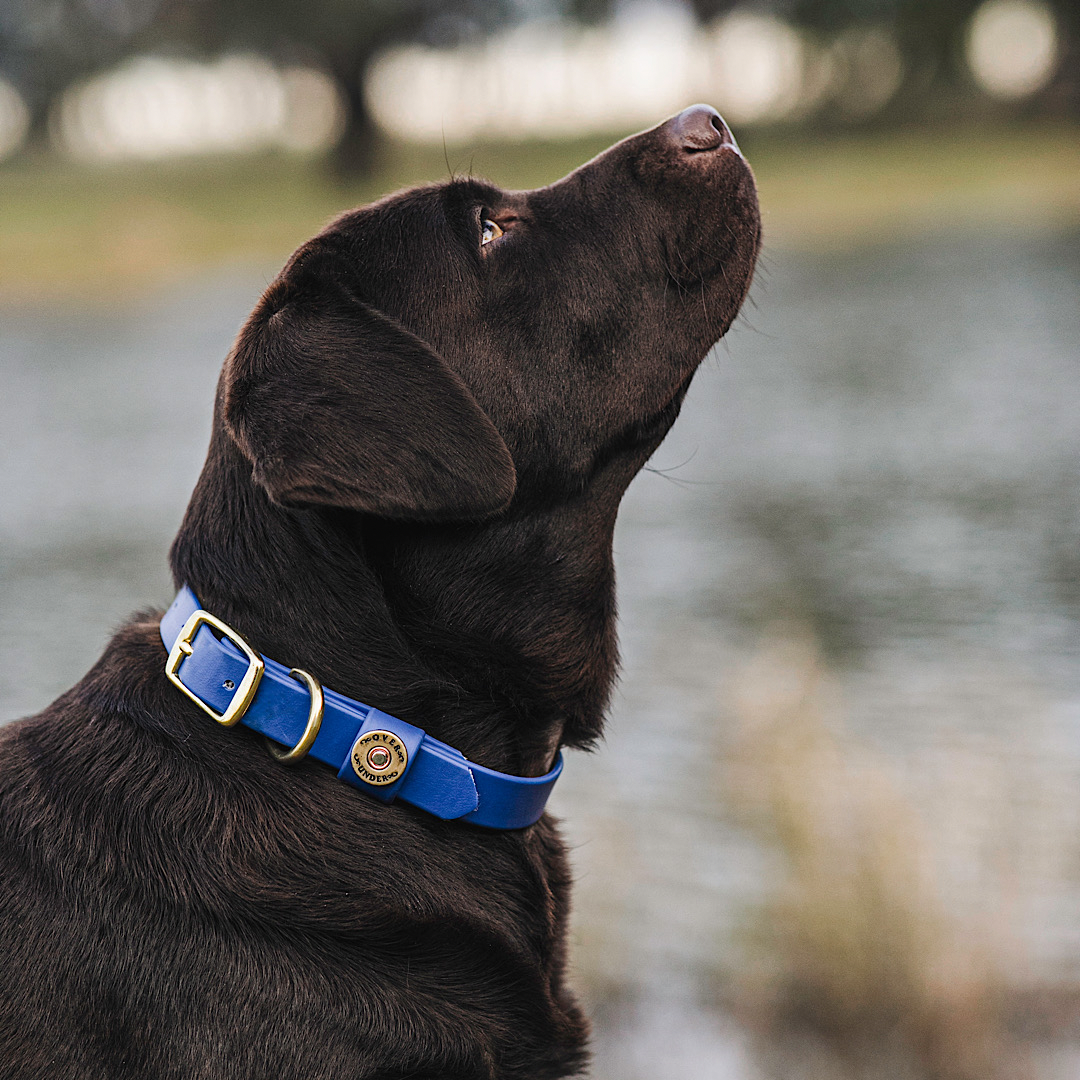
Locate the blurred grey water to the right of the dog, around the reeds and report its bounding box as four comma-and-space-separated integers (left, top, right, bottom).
559, 227, 1080, 973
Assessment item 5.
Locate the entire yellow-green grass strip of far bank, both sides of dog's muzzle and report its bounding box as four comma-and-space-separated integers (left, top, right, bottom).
0, 125, 1080, 303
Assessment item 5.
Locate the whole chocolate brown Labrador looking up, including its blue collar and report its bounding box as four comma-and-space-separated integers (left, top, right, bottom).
0, 106, 760, 1080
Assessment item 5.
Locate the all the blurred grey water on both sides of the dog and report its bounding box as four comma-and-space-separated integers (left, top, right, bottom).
0, 225, 1080, 1080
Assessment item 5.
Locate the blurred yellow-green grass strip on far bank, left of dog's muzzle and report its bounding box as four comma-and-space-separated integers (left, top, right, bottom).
0, 138, 622, 303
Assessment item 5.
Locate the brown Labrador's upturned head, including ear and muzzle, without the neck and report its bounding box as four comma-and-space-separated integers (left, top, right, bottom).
222, 106, 759, 522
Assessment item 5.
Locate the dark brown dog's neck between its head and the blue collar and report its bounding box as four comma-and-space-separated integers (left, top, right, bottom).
171, 426, 629, 775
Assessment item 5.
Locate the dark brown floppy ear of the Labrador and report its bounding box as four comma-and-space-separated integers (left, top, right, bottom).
222, 249, 516, 521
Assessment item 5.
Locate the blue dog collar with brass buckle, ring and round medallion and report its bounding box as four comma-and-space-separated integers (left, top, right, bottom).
161, 585, 563, 828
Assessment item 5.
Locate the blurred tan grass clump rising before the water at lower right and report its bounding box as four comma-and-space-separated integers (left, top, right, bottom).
728, 636, 1027, 1080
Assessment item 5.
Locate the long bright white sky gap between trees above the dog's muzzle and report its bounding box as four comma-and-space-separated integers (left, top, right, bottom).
366, 8, 825, 141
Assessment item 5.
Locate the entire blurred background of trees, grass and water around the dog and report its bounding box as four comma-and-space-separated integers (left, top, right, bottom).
0, 0, 1080, 1080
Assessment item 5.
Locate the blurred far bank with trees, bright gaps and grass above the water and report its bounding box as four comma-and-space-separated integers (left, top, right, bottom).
0, 0, 1080, 298
